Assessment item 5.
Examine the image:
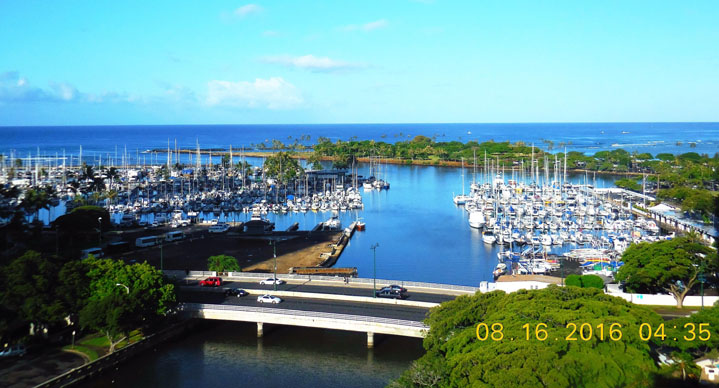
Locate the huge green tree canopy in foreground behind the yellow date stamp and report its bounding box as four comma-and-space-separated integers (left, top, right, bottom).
396, 285, 662, 387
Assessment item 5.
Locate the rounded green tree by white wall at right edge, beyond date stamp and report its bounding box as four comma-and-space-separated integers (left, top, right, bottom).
617, 236, 719, 308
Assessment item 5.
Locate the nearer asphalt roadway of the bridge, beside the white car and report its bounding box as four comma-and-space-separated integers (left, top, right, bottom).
179, 287, 429, 322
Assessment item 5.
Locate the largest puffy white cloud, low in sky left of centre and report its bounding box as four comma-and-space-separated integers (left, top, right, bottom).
207, 77, 302, 109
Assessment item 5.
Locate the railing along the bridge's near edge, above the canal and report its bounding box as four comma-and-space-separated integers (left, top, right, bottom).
181, 303, 429, 330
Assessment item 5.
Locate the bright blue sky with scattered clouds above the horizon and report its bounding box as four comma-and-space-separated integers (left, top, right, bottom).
0, 0, 719, 125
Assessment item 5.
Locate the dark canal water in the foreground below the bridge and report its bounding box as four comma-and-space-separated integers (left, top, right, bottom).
81, 322, 424, 388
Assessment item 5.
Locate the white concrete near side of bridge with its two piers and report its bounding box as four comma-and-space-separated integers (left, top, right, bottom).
182, 303, 429, 348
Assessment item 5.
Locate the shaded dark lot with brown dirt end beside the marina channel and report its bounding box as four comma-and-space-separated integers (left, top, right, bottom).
109, 227, 341, 273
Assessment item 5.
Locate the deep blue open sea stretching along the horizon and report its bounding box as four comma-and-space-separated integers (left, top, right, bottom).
0, 123, 719, 162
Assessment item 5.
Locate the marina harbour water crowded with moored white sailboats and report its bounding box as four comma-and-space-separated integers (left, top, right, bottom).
3, 139, 696, 285
